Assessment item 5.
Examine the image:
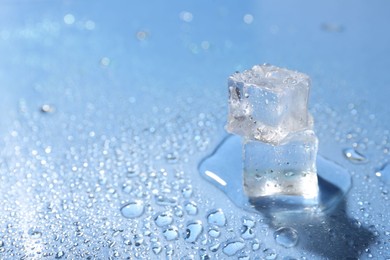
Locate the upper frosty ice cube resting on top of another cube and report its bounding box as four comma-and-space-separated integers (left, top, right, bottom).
226, 65, 313, 144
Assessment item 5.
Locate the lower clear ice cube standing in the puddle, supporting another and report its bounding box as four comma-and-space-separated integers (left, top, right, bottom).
243, 130, 318, 199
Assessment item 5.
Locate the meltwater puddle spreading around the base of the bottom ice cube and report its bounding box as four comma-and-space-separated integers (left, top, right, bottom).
199, 135, 351, 212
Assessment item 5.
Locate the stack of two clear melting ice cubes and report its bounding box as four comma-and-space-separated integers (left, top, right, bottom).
226, 64, 318, 199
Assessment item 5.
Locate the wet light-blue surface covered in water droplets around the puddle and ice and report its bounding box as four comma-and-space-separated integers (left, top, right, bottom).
0, 0, 390, 259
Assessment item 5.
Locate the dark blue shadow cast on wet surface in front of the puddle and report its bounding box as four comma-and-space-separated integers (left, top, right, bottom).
255, 180, 375, 259
